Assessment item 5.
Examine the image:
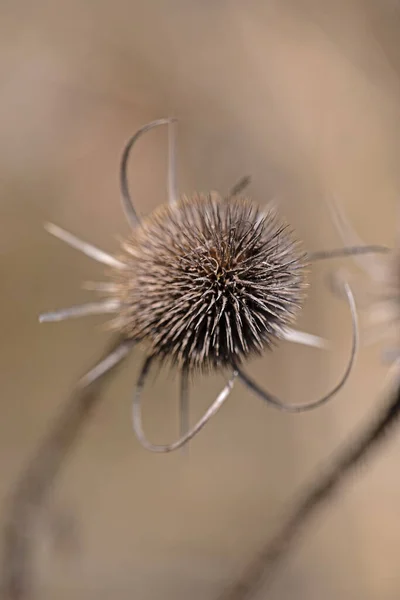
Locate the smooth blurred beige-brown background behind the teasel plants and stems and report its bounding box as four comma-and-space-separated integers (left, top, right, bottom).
0, 0, 400, 600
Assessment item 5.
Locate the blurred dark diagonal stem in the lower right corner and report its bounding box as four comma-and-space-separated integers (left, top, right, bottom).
219, 381, 400, 600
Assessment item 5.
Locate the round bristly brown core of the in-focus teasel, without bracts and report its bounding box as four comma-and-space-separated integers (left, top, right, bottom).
108, 193, 306, 371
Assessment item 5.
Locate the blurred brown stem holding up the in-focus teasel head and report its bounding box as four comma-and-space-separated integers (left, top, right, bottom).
1, 340, 130, 600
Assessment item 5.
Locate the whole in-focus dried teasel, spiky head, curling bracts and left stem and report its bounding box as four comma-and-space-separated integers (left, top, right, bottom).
1, 119, 384, 600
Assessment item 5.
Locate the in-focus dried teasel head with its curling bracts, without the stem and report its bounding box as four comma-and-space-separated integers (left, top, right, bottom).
40, 119, 366, 452
